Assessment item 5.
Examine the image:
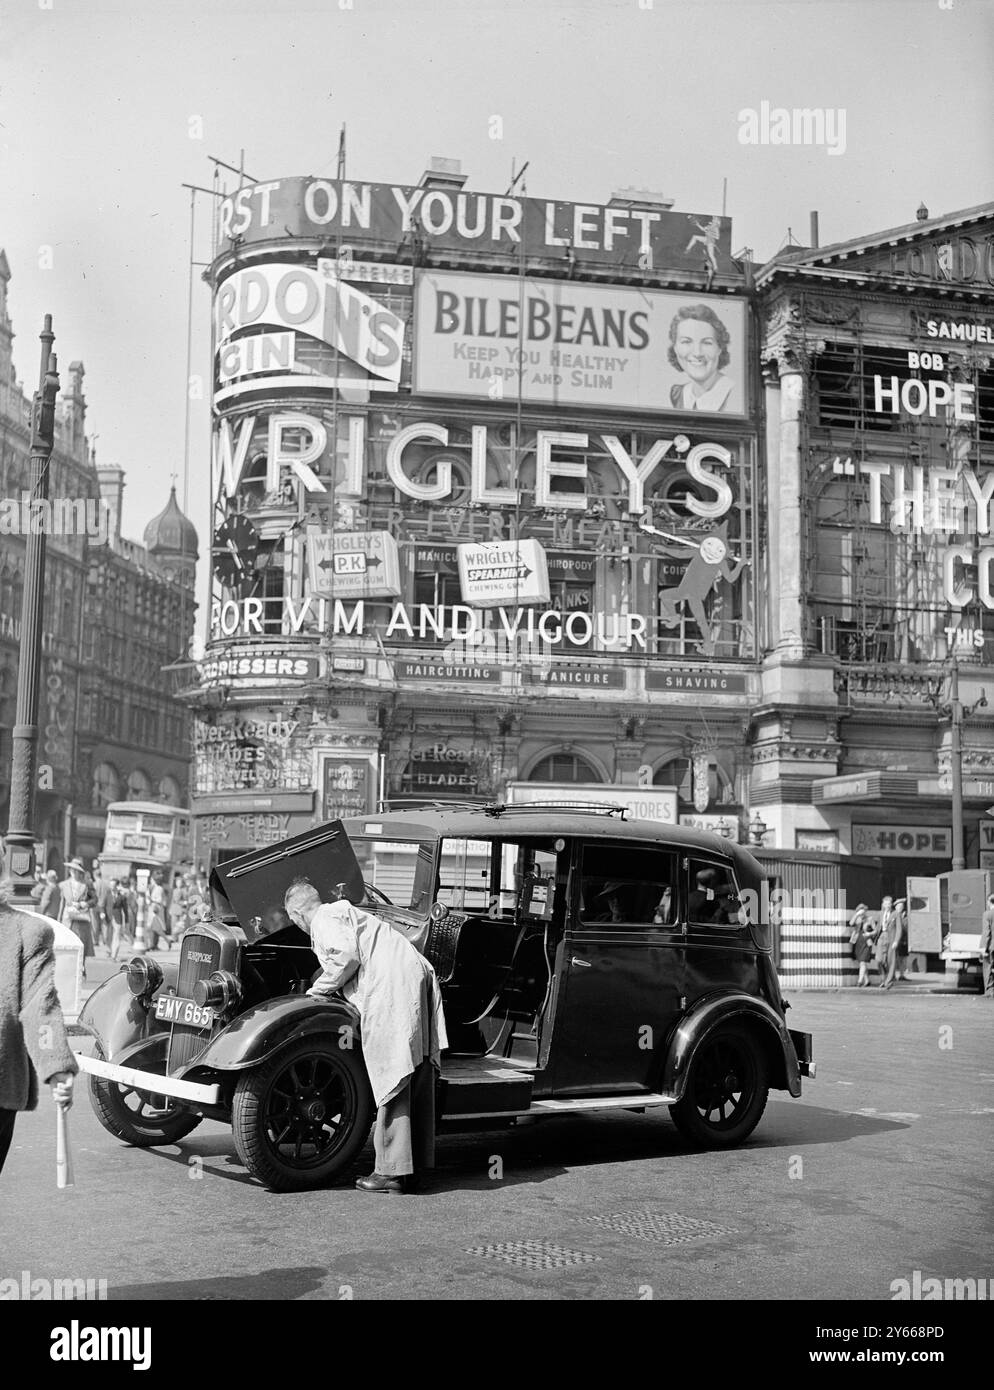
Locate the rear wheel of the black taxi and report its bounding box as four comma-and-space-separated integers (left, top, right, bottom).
670, 1024, 770, 1148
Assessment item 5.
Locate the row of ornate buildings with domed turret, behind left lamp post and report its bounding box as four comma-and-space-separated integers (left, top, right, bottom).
0, 252, 196, 867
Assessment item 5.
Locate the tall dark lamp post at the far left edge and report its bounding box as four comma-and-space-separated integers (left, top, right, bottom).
6, 314, 58, 904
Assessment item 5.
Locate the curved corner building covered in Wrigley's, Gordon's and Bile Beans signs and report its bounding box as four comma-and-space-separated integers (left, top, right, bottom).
188, 161, 763, 856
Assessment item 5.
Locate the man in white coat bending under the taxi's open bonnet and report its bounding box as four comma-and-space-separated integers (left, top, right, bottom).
284, 878, 449, 1193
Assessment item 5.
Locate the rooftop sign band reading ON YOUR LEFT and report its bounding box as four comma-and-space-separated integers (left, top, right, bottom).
220, 175, 741, 275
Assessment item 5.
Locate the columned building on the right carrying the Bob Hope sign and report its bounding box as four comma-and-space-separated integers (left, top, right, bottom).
749, 204, 994, 979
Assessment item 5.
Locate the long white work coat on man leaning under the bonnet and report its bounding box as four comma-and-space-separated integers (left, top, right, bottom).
307, 899, 449, 1105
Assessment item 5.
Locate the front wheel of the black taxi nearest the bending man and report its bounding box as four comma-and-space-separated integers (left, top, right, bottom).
231, 1034, 375, 1193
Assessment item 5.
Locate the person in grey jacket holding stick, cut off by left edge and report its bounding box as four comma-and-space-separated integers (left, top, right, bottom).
0, 883, 78, 1172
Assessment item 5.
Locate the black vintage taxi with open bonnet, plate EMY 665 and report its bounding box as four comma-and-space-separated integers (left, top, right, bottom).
71, 805, 815, 1190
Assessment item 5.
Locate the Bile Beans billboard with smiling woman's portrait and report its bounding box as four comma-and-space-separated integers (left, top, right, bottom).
412, 271, 747, 416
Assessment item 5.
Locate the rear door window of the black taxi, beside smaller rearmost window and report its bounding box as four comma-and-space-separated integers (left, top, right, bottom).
580, 841, 677, 927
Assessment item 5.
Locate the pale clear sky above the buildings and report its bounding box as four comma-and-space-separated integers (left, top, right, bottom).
0, 0, 994, 606
